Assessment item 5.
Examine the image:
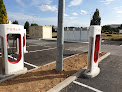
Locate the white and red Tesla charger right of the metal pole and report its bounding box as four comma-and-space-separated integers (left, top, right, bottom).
84, 26, 101, 78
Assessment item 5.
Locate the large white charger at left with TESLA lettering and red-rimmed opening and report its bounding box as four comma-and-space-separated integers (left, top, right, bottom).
0, 24, 24, 75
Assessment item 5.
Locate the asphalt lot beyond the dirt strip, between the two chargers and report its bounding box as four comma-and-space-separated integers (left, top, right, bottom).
0, 39, 88, 70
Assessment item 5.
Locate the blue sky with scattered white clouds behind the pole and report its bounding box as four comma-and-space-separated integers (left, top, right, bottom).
3, 0, 122, 27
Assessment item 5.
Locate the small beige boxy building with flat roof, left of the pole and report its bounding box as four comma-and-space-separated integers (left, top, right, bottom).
29, 26, 52, 39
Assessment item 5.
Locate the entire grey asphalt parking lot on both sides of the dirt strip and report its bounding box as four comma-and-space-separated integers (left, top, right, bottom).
0, 39, 122, 92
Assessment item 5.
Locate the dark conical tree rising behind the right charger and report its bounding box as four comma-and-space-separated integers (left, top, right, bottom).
90, 9, 101, 25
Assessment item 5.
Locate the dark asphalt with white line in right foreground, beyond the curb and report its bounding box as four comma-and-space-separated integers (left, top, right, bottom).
61, 55, 122, 92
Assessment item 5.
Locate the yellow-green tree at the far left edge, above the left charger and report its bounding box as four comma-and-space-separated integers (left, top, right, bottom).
0, 0, 8, 24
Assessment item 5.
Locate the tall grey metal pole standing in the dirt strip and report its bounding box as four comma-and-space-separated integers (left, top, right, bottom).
56, 0, 65, 71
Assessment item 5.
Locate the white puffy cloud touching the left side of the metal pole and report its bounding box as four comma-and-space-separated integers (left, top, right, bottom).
39, 5, 58, 12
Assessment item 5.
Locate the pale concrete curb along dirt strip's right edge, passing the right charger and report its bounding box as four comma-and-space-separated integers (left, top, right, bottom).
47, 53, 110, 92
